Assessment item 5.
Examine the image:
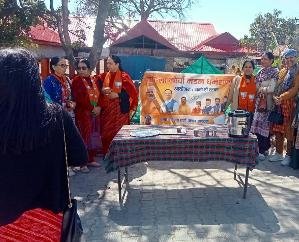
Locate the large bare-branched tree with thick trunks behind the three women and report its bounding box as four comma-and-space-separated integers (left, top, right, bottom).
50, 0, 193, 68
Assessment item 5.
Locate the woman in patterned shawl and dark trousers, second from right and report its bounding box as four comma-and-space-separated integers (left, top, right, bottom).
251, 52, 278, 160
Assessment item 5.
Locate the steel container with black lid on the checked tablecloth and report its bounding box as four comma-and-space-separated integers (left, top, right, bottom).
227, 110, 250, 138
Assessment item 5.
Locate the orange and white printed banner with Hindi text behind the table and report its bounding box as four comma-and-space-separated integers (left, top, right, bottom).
139, 71, 234, 125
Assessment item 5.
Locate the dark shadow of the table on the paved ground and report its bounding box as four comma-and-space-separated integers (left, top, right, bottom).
109, 186, 279, 233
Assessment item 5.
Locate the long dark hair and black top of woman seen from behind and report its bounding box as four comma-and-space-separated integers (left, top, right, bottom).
0, 49, 87, 240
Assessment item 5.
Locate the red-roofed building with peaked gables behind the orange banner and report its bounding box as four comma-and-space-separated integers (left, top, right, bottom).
110, 20, 257, 71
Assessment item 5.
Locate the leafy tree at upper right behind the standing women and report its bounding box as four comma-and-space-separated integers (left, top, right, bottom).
241, 9, 296, 51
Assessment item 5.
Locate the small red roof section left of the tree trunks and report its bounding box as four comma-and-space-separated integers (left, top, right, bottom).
29, 25, 61, 45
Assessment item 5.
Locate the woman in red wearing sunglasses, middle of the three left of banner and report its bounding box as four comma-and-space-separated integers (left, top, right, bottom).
72, 59, 101, 169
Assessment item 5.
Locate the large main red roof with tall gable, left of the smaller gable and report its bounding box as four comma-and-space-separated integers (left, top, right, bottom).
112, 20, 216, 51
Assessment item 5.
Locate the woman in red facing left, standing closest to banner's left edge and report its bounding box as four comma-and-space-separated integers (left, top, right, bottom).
99, 55, 138, 154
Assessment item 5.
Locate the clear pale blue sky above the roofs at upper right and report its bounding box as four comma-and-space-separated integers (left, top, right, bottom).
50, 0, 299, 39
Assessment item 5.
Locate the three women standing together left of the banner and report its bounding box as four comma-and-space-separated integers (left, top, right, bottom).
43, 55, 138, 174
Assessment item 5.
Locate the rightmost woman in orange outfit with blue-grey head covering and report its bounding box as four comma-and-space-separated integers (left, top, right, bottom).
269, 49, 299, 166
